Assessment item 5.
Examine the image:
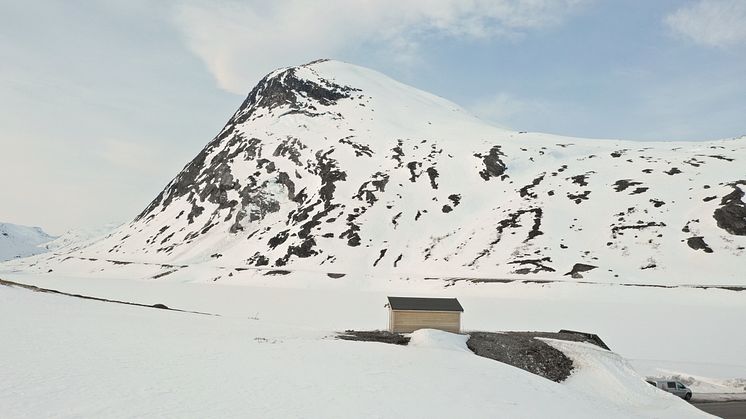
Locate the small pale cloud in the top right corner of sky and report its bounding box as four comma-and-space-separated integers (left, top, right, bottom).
664, 0, 746, 47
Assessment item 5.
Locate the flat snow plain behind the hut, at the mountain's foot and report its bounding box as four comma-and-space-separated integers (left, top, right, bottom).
0, 260, 746, 408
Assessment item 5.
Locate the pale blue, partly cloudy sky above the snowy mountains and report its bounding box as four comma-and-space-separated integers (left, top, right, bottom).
0, 0, 746, 234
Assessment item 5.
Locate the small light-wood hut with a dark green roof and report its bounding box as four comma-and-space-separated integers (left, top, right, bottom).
388, 297, 464, 333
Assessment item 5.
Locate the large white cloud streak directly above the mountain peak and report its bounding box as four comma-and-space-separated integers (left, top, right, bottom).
174, 0, 589, 94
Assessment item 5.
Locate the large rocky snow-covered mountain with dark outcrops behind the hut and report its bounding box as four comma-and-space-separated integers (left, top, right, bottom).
40, 60, 746, 284
